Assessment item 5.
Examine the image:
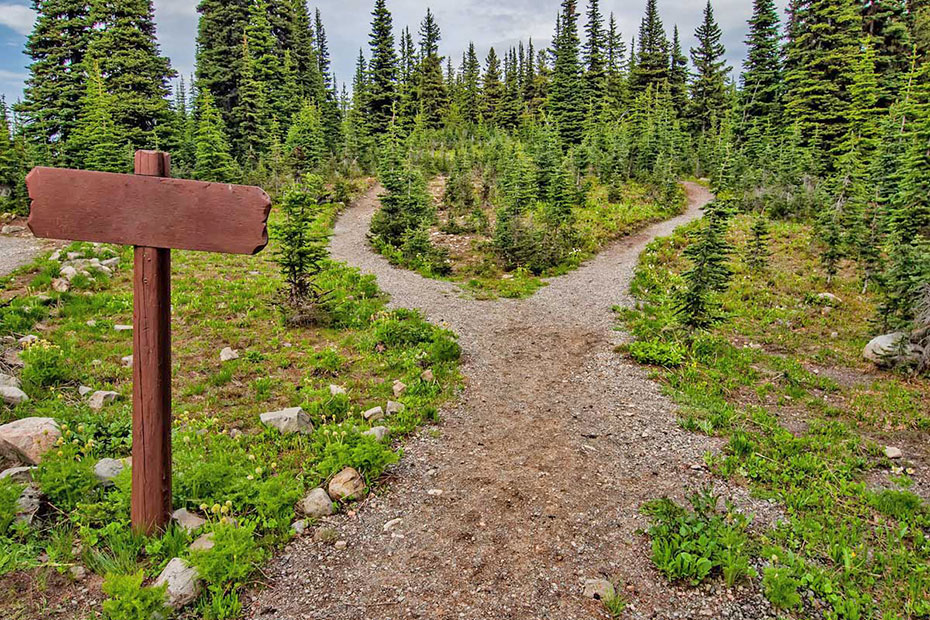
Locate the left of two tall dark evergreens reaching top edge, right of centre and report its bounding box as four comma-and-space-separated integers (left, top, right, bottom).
548, 0, 585, 144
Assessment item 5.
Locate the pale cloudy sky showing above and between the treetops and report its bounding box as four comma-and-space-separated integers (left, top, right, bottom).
0, 0, 788, 103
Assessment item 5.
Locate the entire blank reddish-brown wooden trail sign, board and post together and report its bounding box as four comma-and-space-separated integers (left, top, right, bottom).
26, 151, 271, 534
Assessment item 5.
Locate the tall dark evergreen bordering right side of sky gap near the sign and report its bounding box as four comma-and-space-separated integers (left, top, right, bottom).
196, 0, 248, 125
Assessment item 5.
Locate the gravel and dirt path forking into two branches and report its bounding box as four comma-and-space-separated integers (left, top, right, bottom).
251, 184, 759, 620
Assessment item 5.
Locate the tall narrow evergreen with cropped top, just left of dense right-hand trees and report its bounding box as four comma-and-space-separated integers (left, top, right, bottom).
739, 0, 782, 131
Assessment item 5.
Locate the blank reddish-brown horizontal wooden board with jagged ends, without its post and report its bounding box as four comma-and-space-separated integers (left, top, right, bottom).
26, 163, 271, 254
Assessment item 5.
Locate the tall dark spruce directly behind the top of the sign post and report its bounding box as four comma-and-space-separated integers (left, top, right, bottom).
90, 0, 177, 149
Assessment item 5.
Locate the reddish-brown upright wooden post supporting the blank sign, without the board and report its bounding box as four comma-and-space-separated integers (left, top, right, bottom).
132, 151, 171, 534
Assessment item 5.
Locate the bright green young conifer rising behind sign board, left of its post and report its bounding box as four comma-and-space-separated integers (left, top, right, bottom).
67, 61, 132, 172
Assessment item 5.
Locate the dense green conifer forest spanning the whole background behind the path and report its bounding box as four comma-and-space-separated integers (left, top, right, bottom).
0, 0, 930, 344
